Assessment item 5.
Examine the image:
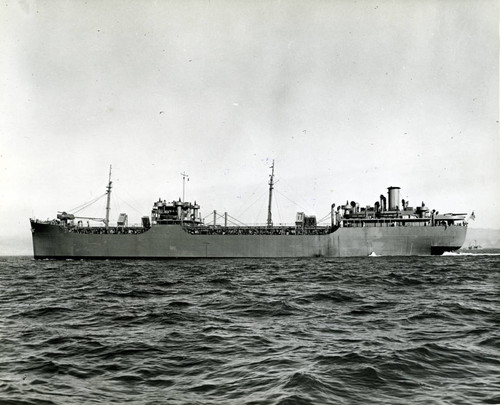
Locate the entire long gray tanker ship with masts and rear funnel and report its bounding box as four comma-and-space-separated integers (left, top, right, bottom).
30, 162, 467, 259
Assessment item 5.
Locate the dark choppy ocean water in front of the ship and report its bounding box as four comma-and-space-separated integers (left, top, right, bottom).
0, 253, 500, 405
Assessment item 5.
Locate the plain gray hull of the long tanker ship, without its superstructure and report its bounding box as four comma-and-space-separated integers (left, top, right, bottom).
31, 221, 467, 259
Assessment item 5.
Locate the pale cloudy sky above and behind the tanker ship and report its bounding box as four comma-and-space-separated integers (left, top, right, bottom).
0, 0, 500, 254
